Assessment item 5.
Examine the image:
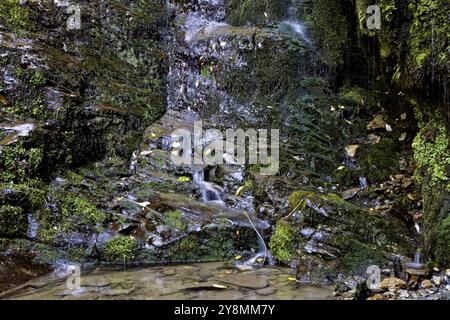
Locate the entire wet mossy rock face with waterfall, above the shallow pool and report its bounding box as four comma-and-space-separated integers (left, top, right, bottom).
0, 0, 450, 290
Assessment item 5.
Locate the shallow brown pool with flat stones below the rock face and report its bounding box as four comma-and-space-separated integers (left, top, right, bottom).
0, 262, 333, 300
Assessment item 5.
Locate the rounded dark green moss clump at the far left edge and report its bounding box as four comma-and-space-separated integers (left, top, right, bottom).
0, 205, 28, 237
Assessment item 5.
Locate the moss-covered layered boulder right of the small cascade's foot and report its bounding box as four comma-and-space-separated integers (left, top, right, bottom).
278, 190, 414, 279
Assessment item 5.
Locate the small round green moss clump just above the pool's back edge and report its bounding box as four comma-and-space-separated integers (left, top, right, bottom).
104, 236, 137, 263
